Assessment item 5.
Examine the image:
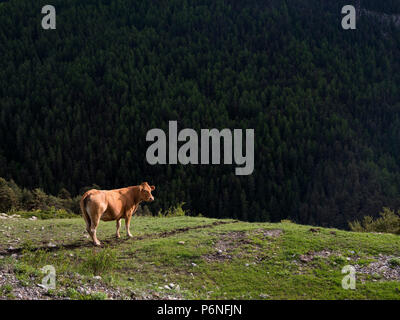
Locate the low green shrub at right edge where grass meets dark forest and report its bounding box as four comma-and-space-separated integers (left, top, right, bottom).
349, 208, 400, 234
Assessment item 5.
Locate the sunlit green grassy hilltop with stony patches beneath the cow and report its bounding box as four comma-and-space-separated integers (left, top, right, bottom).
0, 216, 400, 299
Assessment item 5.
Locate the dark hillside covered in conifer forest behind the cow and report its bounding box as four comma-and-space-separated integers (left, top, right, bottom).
0, 0, 400, 227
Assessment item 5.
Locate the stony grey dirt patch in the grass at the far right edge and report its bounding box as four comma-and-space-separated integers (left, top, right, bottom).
354, 254, 400, 280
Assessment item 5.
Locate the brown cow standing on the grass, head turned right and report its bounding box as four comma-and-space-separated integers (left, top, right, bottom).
80, 182, 155, 246
